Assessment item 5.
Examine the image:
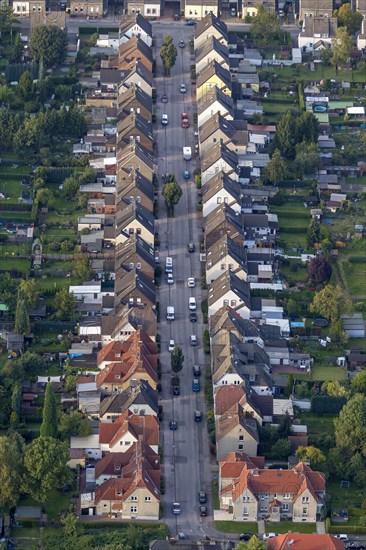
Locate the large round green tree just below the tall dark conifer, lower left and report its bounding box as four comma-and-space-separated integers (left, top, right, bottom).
22, 436, 70, 502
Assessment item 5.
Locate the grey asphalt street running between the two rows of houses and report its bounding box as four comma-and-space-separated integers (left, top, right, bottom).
154, 23, 212, 537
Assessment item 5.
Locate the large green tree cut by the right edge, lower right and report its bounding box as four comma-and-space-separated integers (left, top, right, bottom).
334, 393, 366, 458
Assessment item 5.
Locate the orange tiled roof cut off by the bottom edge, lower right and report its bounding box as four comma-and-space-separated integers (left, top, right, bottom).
267, 533, 344, 550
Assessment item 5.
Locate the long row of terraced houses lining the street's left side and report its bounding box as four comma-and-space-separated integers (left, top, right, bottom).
64, 15, 161, 520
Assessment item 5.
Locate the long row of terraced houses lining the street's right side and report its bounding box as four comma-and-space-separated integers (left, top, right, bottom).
194, 14, 325, 522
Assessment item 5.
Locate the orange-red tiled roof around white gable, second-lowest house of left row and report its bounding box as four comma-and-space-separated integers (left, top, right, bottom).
99, 410, 159, 447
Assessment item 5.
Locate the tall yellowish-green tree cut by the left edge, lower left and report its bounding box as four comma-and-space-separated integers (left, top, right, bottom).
0, 432, 24, 510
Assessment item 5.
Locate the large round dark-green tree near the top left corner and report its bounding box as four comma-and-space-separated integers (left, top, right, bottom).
29, 25, 68, 68
